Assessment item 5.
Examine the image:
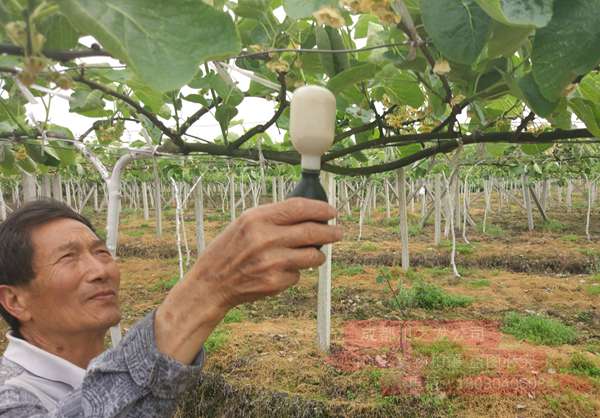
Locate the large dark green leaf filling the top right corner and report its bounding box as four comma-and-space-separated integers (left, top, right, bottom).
531, 0, 600, 101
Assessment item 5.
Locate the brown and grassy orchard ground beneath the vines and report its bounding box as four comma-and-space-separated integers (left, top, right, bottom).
0, 197, 600, 417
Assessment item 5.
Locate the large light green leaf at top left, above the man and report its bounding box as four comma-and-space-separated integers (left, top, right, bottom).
58, 0, 241, 91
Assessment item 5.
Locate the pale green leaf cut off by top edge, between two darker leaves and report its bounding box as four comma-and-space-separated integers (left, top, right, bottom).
475, 0, 554, 28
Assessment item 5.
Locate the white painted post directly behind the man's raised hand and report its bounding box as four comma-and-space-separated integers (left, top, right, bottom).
317, 173, 336, 352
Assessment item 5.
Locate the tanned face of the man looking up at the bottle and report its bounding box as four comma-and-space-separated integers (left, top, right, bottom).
22, 219, 121, 334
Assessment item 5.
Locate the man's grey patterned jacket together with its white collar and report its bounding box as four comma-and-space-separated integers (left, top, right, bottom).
0, 312, 204, 418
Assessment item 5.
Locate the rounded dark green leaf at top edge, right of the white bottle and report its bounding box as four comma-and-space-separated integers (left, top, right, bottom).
421, 0, 492, 64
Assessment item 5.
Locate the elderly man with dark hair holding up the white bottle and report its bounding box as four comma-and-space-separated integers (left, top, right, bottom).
0, 199, 342, 417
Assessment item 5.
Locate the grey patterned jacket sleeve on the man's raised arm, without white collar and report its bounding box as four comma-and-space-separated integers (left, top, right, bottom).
0, 311, 205, 418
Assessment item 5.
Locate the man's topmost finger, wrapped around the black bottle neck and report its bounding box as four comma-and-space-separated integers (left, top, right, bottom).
265, 197, 337, 225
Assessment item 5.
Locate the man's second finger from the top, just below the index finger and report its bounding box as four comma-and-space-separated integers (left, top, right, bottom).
277, 222, 343, 248
